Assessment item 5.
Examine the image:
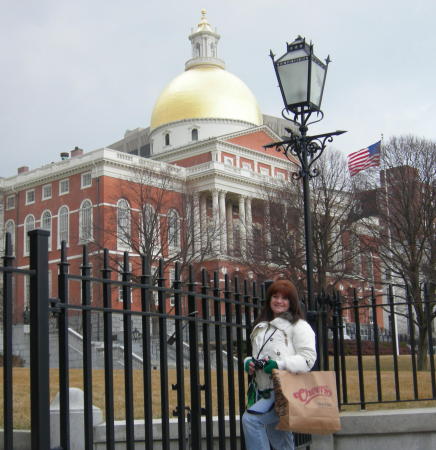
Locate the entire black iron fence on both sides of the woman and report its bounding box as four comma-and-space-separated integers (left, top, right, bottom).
0, 230, 436, 450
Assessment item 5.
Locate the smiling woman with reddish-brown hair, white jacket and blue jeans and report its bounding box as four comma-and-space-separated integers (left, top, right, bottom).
242, 280, 316, 450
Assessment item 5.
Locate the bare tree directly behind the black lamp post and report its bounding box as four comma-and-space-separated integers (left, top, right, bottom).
244, 151, 358, 292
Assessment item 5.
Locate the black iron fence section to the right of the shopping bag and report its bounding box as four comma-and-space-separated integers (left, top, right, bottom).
319, 285, 436, 409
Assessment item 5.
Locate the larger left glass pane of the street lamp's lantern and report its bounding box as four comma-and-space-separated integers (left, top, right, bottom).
277, 55, 309, 106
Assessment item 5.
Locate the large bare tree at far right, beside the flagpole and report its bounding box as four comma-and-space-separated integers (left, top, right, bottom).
358, 136, 436, 369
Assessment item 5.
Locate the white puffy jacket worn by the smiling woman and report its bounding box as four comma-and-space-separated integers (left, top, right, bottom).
245, 317, 316, 390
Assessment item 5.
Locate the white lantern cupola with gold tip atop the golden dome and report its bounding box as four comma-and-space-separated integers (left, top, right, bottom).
185, 9, 225, 70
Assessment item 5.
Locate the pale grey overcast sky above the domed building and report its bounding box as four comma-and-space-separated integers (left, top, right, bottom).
0, 0, 436, 177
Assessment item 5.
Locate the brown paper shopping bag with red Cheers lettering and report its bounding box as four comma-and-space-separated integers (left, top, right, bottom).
273, 370, 341, 434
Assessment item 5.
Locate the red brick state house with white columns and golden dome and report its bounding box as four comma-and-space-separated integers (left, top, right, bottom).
0, 11, 380, 323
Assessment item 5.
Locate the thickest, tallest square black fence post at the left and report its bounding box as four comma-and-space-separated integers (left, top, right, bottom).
29, 230, 50, 450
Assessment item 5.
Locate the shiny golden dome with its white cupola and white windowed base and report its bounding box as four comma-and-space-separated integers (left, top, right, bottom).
150, 10, 262, 154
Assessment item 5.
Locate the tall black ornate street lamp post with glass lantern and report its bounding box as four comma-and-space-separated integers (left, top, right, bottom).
265, 36, 345, 326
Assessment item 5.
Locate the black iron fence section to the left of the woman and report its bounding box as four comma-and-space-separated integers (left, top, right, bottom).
0, 230, 310, 450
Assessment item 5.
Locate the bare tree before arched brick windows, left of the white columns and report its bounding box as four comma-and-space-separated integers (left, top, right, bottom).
104, 165, 219, 281
